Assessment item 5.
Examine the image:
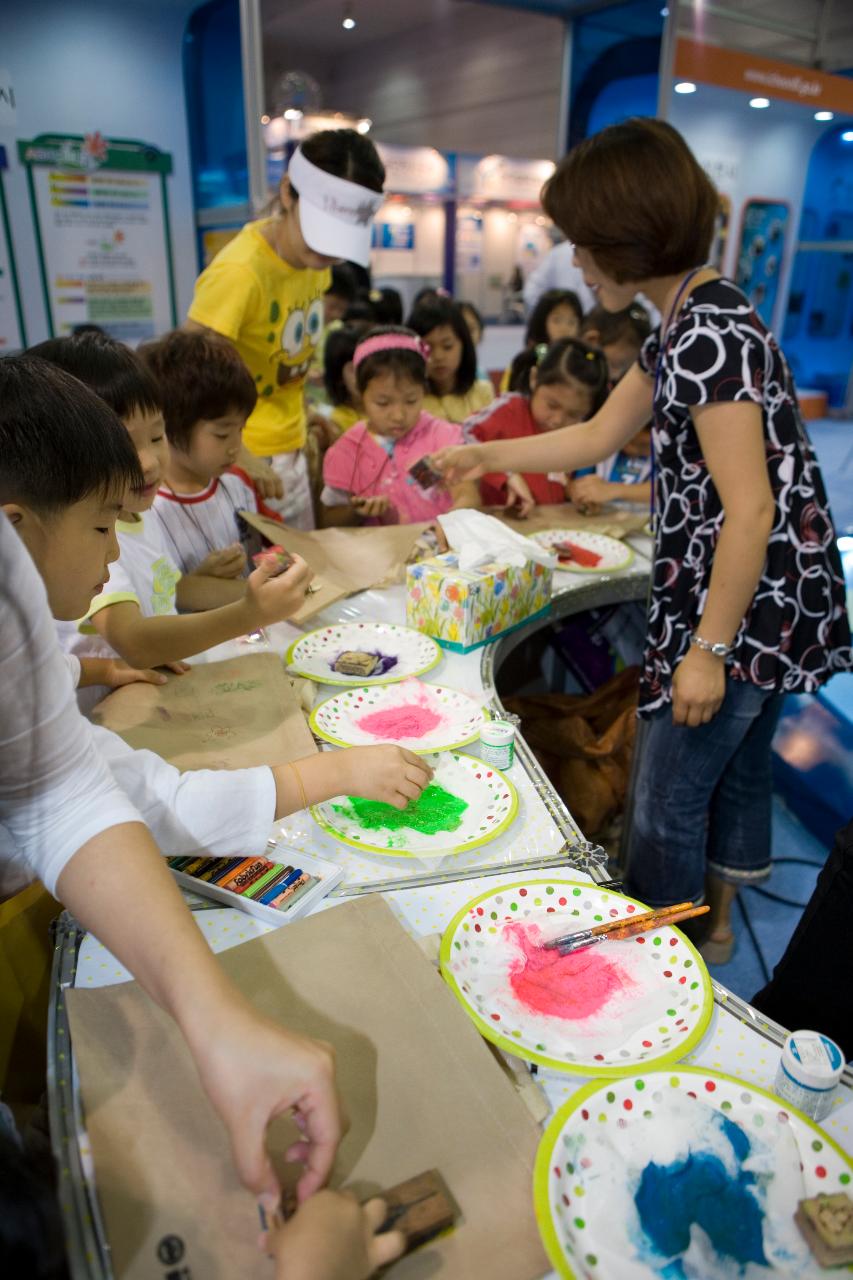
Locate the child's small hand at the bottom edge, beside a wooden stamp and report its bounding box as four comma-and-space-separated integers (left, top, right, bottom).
266, 1190, 406, 1280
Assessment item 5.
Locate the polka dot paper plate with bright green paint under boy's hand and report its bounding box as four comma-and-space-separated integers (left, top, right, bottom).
311, 751, 519, 858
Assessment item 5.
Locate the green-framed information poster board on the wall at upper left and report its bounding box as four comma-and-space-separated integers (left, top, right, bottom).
18, 133, 177, 346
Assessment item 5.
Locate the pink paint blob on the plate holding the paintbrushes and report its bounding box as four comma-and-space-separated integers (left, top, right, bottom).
503, 924, 634, 1021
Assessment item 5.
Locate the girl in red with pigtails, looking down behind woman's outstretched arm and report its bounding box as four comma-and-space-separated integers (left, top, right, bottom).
465, 338, 607, 517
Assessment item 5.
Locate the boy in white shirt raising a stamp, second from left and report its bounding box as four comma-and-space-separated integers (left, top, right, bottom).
29, 334, 311, 686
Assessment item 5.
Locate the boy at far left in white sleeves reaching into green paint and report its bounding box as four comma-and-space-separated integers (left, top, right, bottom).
0, 356, 430, 897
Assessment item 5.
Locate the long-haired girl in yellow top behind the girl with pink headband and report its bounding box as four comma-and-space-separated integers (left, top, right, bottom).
409, 298, 494, 424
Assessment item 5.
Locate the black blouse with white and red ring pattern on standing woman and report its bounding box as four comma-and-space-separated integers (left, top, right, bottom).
640, 279, 853, 713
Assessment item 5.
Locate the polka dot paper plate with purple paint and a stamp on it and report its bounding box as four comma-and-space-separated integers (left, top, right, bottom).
284, 622, 442, 685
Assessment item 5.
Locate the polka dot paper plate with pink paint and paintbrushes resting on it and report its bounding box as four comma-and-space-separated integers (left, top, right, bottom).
441, 879, 713, 1076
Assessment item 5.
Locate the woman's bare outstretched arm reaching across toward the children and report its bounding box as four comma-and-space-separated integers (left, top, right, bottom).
432, 365, 654, 485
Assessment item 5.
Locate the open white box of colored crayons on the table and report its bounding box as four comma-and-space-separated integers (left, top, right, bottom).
168, 845, 343, 924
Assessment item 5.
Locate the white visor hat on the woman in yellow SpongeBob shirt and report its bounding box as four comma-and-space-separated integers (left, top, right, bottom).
287, 147, 384, 266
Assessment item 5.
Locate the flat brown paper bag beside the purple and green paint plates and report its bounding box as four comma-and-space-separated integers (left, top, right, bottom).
92, 653, 316, 769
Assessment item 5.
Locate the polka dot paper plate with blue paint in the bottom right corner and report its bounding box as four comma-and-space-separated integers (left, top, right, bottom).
534, 1068, 853, 1280
